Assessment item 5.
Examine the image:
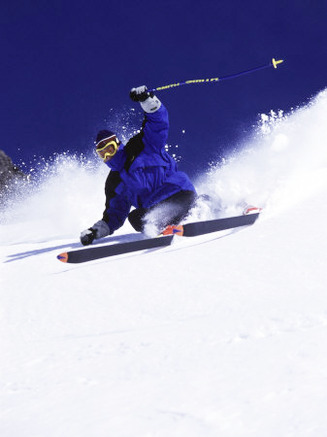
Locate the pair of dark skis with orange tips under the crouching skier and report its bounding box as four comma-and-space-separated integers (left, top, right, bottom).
57, 213, 259, 263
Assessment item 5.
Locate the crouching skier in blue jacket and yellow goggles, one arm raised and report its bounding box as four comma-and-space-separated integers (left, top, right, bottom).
80, 86, 197, 245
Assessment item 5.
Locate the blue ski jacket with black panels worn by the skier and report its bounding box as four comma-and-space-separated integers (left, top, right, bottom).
103, 104, 195, 233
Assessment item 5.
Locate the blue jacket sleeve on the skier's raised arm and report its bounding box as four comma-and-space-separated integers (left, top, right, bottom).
143, 104, 169, 152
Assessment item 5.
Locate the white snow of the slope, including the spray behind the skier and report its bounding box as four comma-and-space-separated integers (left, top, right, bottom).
0, 90, 327, 437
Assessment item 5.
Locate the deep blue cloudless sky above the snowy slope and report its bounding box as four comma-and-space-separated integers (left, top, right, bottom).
0, 0, 327, 173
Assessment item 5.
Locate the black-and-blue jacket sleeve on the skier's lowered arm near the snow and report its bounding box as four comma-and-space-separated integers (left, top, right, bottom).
103, 171, 131, 234
